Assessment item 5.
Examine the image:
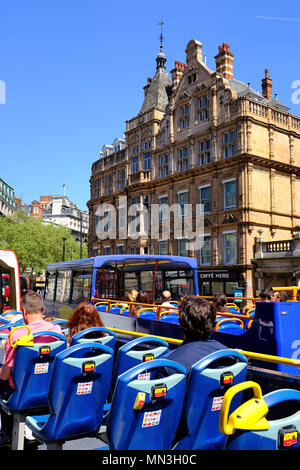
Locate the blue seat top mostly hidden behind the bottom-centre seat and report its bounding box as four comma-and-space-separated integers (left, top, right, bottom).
112, 336, 169, 386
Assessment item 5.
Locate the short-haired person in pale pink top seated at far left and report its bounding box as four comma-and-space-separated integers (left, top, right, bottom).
0, 291, 62, 445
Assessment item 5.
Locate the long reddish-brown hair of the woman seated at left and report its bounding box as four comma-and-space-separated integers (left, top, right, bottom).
67, 302, 106, 344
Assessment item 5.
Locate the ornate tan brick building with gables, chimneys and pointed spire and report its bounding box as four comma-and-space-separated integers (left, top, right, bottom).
88, 40, 300, 296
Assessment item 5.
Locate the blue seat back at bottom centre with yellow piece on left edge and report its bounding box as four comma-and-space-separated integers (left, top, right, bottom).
107, 359, 186, 450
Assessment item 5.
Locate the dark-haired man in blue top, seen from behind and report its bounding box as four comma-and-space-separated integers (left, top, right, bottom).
161, 296, 227, 373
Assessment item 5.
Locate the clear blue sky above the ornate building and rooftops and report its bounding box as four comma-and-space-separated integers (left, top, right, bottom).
0, 0, 300, 209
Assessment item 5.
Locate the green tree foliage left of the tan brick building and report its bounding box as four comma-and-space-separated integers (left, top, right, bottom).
0, 210, 87, 273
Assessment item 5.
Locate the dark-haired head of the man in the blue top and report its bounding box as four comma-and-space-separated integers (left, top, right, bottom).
178, 296, 216, 340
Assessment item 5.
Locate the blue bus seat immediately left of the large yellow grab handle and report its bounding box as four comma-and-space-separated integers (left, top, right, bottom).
174, 349, 248, 450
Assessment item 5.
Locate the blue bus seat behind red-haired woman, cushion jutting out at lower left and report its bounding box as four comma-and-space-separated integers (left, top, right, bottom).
26, 342, 114, 449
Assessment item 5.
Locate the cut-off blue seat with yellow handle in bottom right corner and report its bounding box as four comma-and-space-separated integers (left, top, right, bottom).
221, 381, 300, 450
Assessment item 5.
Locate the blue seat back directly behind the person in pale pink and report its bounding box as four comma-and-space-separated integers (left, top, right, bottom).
6, 331, 67, 411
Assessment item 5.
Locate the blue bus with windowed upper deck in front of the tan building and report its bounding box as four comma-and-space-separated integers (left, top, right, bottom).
45, 255, 199, 338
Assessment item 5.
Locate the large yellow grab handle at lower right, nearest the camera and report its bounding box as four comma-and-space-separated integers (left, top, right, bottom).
219, 381, 269, 435
